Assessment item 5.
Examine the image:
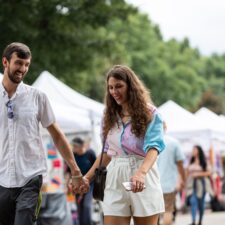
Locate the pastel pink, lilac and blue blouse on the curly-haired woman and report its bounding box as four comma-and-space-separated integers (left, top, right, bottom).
104, 107, 165, 157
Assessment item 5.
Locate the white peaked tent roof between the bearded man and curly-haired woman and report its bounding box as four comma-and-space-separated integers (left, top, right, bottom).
32, 71, 104, 133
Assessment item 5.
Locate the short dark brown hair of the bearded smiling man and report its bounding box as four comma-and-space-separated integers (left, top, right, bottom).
2, 42, 32, 61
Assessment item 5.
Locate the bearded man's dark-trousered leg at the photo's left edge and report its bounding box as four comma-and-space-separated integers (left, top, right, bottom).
0, 186, 15, 225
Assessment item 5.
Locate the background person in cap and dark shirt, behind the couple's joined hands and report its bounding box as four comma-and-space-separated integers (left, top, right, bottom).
67, 137, 96, 225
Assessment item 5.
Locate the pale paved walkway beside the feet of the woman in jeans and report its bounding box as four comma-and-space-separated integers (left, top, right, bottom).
174, 211, 225, 225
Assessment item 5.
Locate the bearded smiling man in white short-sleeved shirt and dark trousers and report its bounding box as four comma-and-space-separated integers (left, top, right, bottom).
0, 42, 85, 225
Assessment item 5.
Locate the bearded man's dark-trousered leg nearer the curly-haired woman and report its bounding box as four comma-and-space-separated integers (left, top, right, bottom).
14, 175, 42, 225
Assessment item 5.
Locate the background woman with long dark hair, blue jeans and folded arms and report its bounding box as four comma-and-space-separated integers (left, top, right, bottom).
187, 145, 213, 225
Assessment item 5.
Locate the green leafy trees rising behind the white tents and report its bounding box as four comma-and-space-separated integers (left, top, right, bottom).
0, 0, 225, 113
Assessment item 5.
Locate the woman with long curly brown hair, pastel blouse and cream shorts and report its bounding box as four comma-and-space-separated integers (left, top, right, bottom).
81, 65, 164, 225
